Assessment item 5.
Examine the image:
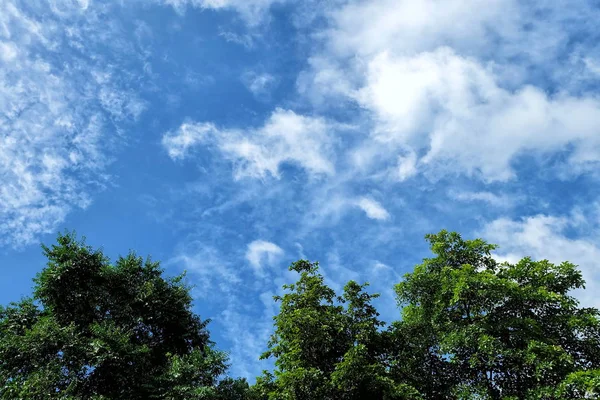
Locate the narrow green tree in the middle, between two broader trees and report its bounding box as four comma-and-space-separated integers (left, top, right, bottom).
258, 260, 420, 400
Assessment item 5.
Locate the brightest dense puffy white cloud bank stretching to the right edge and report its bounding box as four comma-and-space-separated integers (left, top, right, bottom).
357, 49, 600, 180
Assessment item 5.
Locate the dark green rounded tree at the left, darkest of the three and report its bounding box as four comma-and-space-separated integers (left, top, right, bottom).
0, 234, 237, 399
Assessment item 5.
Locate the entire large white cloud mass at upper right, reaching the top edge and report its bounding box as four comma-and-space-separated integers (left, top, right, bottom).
298, 0, 600, 181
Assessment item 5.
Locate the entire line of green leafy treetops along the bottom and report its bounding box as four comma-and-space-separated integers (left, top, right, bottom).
0, 231, 600, 400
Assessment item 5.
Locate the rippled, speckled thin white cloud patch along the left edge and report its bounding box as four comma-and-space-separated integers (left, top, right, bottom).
0, 1, 144, 246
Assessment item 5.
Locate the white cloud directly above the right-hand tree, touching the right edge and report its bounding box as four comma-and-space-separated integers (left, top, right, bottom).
481, 214, 600, 307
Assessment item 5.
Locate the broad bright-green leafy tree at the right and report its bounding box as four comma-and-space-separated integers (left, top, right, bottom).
396, 231, 600, 399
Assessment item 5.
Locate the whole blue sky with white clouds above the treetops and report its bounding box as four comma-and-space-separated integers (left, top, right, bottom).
0, 0, 600, 377
